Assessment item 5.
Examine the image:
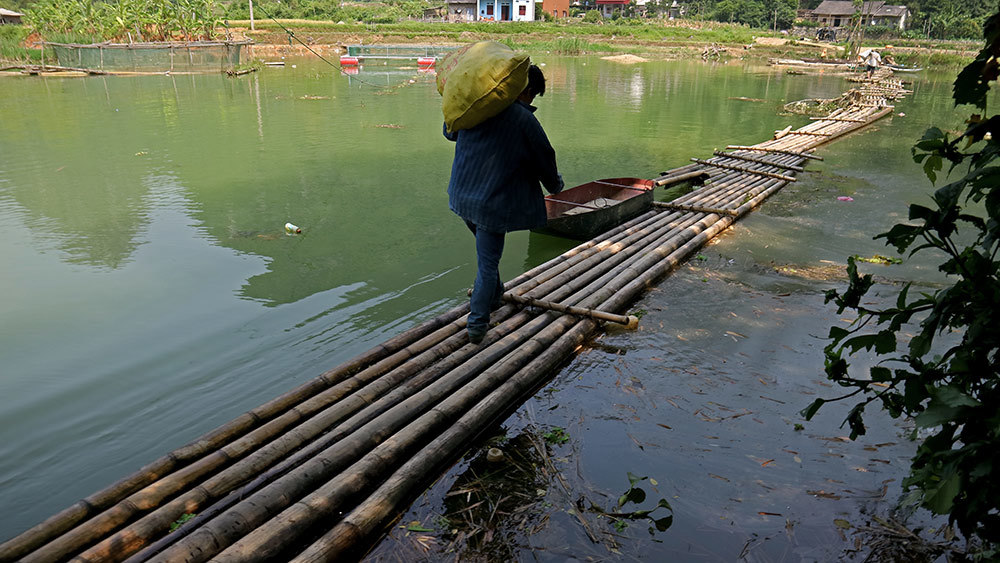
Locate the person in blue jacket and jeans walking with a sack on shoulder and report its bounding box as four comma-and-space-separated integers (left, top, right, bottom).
444, 65, 563, 344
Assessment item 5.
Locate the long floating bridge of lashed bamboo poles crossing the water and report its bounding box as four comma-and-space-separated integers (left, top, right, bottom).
0, 71, 907, 563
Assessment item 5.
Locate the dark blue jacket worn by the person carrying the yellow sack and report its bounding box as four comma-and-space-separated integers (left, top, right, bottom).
444, 101, 562, 233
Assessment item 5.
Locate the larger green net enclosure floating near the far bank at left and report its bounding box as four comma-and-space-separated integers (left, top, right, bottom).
45, 40, 253, 72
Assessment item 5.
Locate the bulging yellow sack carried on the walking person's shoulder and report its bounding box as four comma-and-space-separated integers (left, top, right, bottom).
437, 41, 531, 133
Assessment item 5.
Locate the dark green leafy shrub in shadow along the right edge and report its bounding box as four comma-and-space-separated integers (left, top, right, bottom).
803, 7, 1000, 560
